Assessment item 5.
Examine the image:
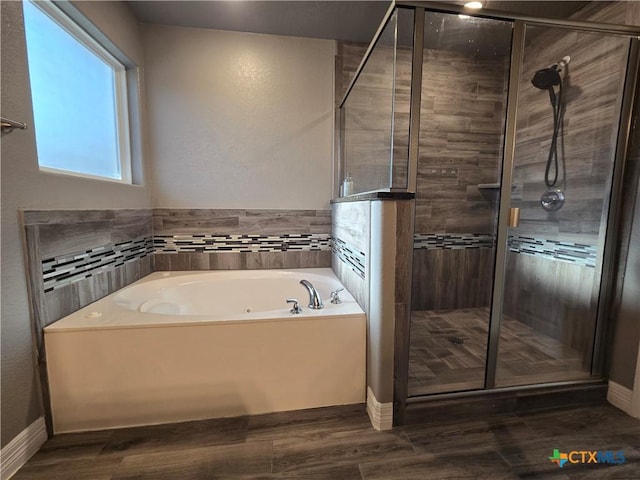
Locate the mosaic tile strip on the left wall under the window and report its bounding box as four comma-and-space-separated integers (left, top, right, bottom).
42, 237, 153, 293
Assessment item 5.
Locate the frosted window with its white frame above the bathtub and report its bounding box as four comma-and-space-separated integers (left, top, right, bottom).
23, 1, 131, 183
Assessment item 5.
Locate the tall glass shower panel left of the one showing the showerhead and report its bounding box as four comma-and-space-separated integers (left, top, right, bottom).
409, 12, 512, 396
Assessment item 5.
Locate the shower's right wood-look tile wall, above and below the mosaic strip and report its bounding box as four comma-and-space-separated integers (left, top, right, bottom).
504, 2, 629, 356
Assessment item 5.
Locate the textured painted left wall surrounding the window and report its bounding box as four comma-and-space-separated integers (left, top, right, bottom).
0, 2, 151, 447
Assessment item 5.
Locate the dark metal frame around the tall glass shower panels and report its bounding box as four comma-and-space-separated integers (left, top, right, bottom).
392, 0, 640, 412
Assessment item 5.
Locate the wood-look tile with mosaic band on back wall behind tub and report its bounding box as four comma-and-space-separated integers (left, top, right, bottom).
153, 209, 331, 270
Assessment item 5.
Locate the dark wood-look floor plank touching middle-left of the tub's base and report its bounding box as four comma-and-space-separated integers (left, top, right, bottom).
100, 417, 248, 457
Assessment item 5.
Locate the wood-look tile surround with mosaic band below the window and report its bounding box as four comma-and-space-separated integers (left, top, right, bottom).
21, 210, 153, 432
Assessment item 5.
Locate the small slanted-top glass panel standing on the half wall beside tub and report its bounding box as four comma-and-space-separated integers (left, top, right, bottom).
342, 11, 397, 194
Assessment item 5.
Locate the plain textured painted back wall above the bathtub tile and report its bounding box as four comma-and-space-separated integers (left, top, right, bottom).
143, 25, 335, 209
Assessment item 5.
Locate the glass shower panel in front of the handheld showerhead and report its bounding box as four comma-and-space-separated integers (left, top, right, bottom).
496, 27, 629, 386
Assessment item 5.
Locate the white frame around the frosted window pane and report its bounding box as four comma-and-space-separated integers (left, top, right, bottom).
24, 0, 132, 184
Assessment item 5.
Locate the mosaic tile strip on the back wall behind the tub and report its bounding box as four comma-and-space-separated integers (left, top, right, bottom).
153, 233, 331, 253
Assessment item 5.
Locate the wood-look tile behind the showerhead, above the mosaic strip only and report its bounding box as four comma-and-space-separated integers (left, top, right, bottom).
513, 21, 629, 245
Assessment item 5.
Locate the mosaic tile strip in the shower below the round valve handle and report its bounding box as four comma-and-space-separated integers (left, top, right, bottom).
509, 235, 598, 268
